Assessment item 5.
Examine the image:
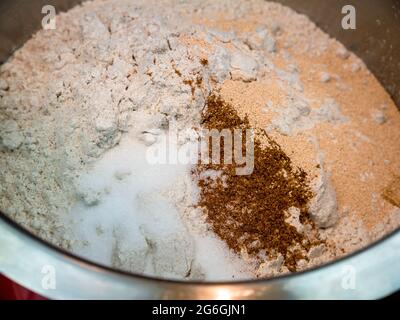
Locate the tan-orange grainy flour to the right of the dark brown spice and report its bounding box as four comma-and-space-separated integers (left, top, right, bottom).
188, 0, 400, 270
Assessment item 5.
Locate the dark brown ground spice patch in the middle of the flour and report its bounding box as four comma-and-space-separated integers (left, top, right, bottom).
195, 94, 324, 271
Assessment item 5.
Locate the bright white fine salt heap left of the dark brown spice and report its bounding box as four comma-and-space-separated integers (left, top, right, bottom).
67, 136, 193, 278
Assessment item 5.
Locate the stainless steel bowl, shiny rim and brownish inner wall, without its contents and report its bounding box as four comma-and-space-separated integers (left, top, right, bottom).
0, 0, 400, 299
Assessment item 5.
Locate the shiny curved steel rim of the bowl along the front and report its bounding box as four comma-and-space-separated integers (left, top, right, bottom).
0, 215, 400, 299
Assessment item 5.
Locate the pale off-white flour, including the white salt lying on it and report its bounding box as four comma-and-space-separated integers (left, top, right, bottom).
0, 0, 394, 280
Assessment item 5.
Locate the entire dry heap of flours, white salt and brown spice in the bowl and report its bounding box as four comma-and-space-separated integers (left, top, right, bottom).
0, 0, 400, 280
